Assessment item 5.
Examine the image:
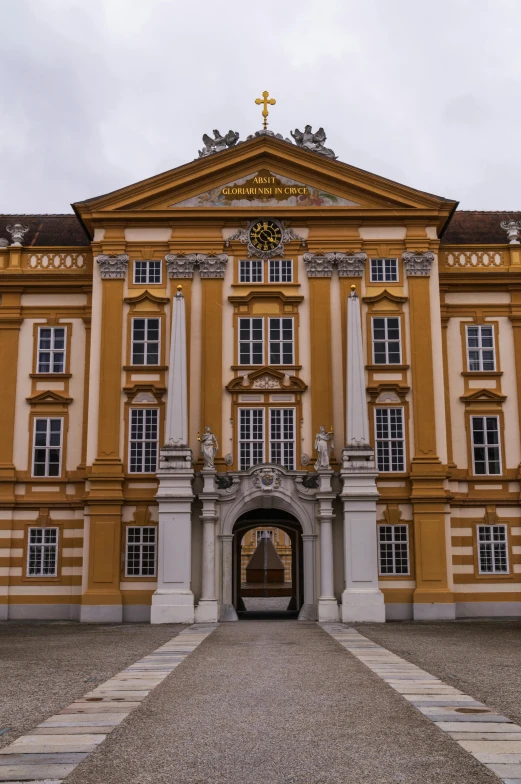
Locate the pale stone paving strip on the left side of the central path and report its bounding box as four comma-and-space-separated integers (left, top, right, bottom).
0, 624, 216, 784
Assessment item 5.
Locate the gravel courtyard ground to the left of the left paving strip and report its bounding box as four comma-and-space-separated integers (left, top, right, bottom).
0, 621, 185, 748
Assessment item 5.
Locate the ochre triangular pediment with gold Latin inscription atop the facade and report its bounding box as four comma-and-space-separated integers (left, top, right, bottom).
73, 137, 456, 236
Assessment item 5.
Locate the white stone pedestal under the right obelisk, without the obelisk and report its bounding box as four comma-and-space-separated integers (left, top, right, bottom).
341, 445, 385, 623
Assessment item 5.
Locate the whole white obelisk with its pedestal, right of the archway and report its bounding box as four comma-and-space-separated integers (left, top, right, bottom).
340, 287, 385, 623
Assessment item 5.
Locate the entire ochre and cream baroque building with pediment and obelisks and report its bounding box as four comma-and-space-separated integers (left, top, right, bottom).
0, 124, 521, 622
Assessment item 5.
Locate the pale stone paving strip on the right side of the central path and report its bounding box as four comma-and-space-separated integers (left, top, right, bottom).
320, 623, 521, 784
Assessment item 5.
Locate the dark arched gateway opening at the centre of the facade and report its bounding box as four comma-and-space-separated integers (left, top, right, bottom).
232, 509, 304, 620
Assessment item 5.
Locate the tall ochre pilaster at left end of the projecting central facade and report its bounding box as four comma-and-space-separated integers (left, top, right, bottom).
80, 253, 128, 623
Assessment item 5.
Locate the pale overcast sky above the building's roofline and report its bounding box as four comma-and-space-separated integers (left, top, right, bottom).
0, 0, 521, 213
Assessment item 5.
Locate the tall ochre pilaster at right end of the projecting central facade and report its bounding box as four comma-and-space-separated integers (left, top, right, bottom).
403, 251, 455, 620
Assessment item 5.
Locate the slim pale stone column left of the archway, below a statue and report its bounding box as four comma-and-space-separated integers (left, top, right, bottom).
195, 468, 219, 623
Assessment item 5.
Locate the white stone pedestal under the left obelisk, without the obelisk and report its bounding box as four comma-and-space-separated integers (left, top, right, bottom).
150, 444, 195, 623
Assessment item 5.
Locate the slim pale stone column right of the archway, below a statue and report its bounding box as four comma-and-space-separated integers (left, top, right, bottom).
316, 468, 338, 622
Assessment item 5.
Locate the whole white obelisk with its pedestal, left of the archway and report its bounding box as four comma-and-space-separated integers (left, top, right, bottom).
151, 287, 194, 623
